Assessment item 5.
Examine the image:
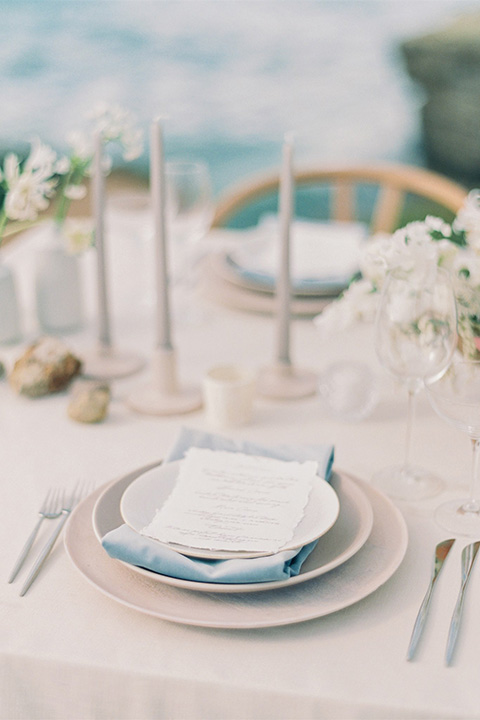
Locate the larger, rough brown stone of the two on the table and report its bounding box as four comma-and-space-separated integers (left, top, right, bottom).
9, 337, 82, 398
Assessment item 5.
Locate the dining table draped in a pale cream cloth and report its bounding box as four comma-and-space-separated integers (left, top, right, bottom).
0, 219, 480, 720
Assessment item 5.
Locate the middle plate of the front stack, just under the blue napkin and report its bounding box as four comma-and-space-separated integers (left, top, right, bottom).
92, 473, 373, 593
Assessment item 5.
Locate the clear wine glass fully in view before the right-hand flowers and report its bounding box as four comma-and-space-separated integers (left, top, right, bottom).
373, 267, 457, 500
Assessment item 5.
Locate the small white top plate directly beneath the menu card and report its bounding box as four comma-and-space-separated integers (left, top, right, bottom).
120, 460, 340, 560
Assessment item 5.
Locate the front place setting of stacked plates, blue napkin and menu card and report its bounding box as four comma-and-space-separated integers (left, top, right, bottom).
65, 428, 408, 628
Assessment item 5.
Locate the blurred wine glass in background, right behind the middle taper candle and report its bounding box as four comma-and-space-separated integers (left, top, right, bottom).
165, 161, 214, 298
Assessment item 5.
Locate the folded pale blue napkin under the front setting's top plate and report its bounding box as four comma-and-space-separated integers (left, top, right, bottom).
102, 428, 334, 583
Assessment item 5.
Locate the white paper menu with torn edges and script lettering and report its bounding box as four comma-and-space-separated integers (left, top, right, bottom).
142, 448, 318, 553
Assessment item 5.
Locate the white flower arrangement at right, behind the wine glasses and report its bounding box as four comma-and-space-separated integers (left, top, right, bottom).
314, 190, 480, 357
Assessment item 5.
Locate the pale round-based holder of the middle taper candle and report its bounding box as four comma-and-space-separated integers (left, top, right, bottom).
128, 348, 202, 415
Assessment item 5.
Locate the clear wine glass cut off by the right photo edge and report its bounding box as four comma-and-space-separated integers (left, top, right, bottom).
425, 358, 480, 537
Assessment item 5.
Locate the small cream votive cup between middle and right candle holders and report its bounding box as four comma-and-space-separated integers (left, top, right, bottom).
203, 365, 256, 428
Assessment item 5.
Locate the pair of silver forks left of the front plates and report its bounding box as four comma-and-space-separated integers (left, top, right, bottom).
8, 483, 87, 596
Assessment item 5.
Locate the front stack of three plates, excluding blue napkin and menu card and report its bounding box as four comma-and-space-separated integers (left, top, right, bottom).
65, 463, 407, 628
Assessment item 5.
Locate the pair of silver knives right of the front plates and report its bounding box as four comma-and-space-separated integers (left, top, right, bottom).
407, 539, 480, 665
